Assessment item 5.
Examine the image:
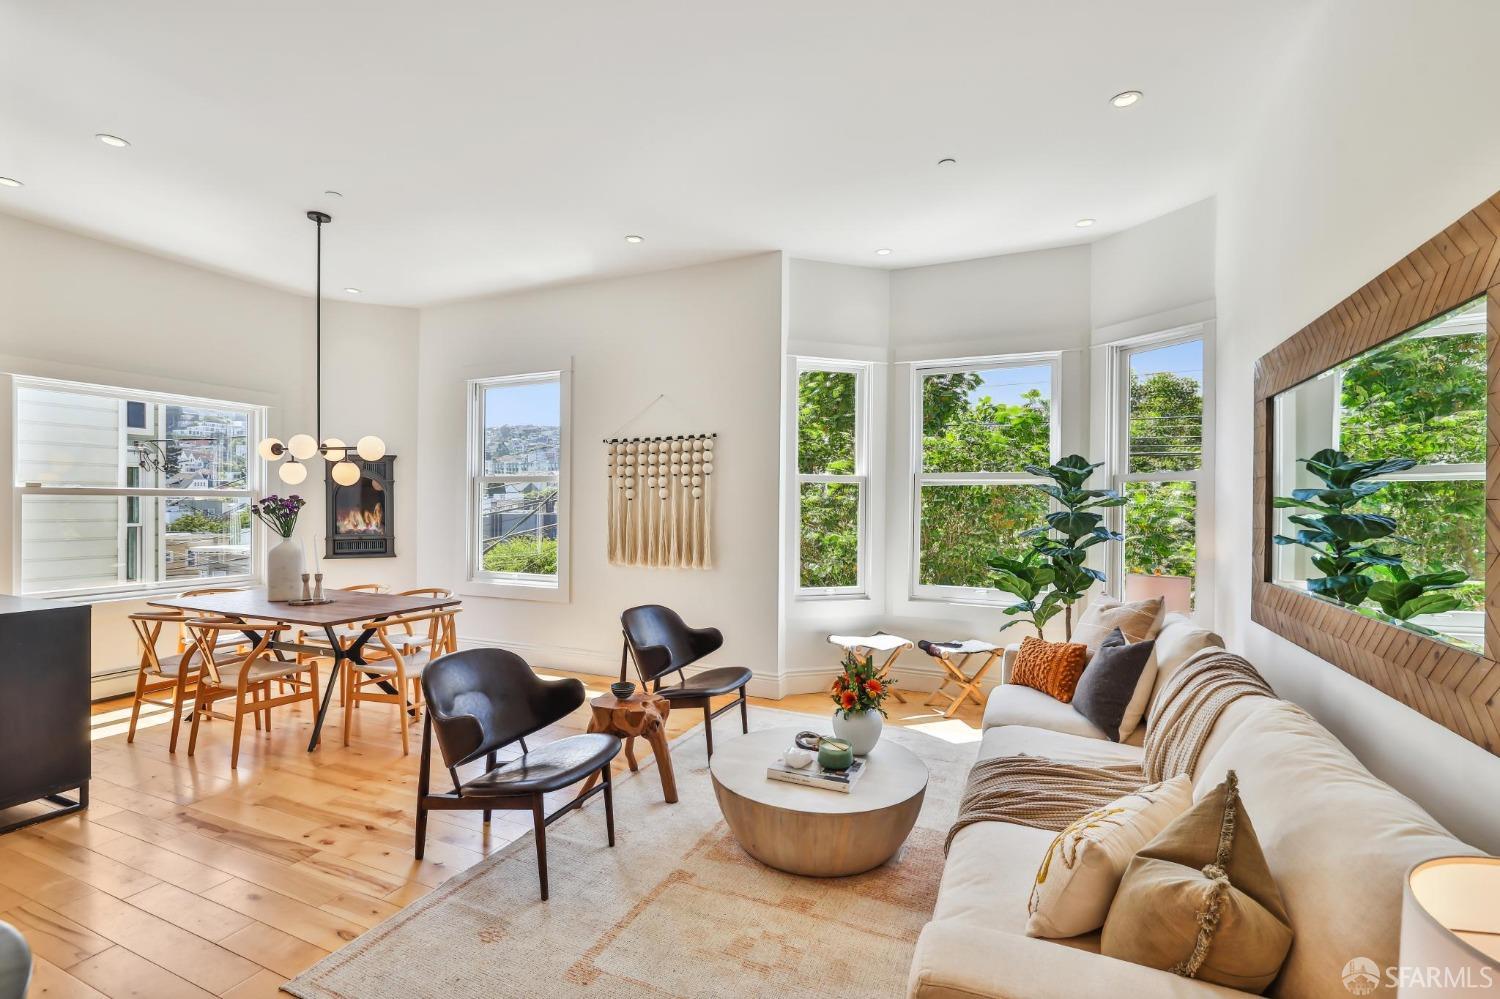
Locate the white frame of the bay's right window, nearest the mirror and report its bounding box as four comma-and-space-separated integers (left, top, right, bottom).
1106, 321, 1215, 621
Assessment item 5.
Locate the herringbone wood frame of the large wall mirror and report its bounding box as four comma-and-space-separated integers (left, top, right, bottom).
1251, 194, 1500, 755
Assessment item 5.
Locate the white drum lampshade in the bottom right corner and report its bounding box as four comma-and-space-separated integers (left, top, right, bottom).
1397, 857, 1500, 999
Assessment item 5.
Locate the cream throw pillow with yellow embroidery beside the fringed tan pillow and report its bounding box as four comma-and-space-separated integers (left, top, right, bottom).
1026, 776, 1193, 939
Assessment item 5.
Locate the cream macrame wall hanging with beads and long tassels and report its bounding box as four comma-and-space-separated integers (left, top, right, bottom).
605, 434, 719, 569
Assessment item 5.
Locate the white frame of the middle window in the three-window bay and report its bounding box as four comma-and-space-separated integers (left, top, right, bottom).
908, 351, 1062, 608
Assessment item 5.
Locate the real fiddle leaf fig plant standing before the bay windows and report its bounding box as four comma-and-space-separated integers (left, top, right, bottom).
990, 455, 1125, 639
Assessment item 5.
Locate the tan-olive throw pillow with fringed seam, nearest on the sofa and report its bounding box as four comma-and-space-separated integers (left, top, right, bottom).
1100, 771, 1292, 995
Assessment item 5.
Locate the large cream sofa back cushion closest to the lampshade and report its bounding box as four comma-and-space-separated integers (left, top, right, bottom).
1194, 698, 1479, 996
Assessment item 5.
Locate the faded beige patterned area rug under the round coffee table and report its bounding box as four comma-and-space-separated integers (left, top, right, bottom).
284, 708, 978, 999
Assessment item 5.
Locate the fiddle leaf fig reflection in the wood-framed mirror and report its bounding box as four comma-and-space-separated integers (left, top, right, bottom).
1272, 449, 1469, 635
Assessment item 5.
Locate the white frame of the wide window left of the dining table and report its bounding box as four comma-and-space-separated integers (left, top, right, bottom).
11, 375, 269, 600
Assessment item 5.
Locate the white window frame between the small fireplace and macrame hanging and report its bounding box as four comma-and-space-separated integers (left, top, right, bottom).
465, 371, 573, 602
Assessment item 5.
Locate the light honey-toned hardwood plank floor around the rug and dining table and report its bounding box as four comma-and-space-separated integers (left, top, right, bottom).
0, 674, 980, 999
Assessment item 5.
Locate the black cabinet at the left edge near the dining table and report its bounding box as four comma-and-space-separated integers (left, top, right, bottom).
0, 596, 90, 833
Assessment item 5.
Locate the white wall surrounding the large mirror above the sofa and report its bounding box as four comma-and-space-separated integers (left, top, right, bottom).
1217, 0, 1500, 852
